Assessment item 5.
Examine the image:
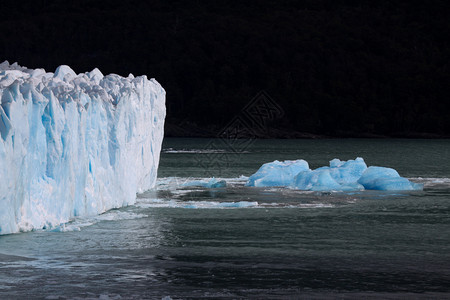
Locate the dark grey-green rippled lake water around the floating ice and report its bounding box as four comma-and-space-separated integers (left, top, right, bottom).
0, 139, 450, 299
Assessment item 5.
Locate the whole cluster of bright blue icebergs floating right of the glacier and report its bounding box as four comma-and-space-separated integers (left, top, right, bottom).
246, 157, 423, 191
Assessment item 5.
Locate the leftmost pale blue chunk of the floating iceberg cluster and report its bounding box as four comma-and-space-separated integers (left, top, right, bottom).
246, 159, 309, 187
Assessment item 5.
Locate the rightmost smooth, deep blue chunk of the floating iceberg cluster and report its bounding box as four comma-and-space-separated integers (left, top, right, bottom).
358, 167, 423, 191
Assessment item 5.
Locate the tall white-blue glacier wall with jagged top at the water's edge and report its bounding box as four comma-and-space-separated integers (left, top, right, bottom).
0, 61, 166, 234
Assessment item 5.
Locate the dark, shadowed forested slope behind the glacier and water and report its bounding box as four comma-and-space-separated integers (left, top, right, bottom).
0, 0, 450, 137
